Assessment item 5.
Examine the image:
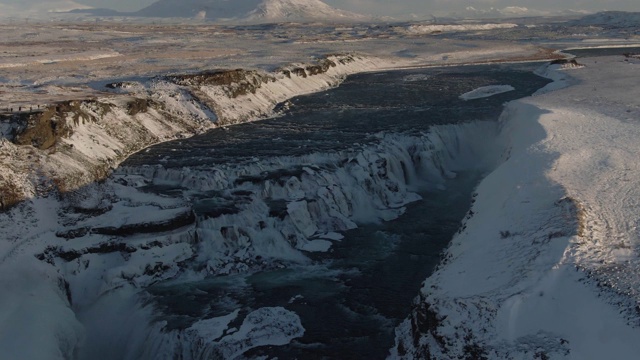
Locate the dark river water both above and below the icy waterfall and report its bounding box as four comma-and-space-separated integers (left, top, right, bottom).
124, 64, 548, 359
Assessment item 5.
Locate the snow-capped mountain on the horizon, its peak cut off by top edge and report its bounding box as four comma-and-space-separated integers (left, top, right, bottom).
133, 0, 369, 21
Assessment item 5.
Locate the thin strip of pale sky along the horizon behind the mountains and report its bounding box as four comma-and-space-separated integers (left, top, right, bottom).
0, 0, 640, 16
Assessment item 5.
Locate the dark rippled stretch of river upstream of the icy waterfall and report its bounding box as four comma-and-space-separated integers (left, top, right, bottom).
123, 64, 548, 168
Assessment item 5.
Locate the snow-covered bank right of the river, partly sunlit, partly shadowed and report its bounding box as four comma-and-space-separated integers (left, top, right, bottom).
390, 57, 640, 359
